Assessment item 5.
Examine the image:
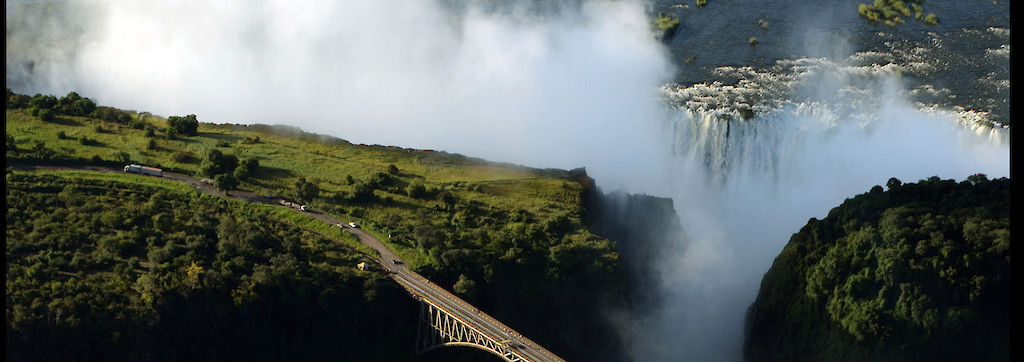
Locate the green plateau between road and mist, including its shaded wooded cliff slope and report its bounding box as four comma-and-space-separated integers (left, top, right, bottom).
5, 89, 629, 360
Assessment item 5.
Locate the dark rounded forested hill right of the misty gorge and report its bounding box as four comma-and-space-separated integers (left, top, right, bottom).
744, 175, 1011, 361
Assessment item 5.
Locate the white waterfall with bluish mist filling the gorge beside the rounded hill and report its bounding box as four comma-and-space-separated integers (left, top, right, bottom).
634, 64, 1010, 361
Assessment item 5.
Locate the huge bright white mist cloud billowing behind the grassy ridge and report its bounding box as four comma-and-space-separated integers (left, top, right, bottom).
7, 0, 672, 192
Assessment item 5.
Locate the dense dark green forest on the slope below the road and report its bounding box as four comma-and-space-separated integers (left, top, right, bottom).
5, 171, 417, 361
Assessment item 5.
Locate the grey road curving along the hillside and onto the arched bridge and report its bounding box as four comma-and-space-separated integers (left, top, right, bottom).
11, 165, 564, 361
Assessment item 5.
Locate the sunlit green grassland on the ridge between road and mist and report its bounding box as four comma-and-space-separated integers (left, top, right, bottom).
5, 93, 598, 266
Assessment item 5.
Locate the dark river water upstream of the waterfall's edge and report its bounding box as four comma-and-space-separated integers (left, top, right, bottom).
652, 0, 1011, 125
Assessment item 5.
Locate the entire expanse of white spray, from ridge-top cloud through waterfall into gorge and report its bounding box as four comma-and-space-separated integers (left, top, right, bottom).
6, 1, 1009, 361
